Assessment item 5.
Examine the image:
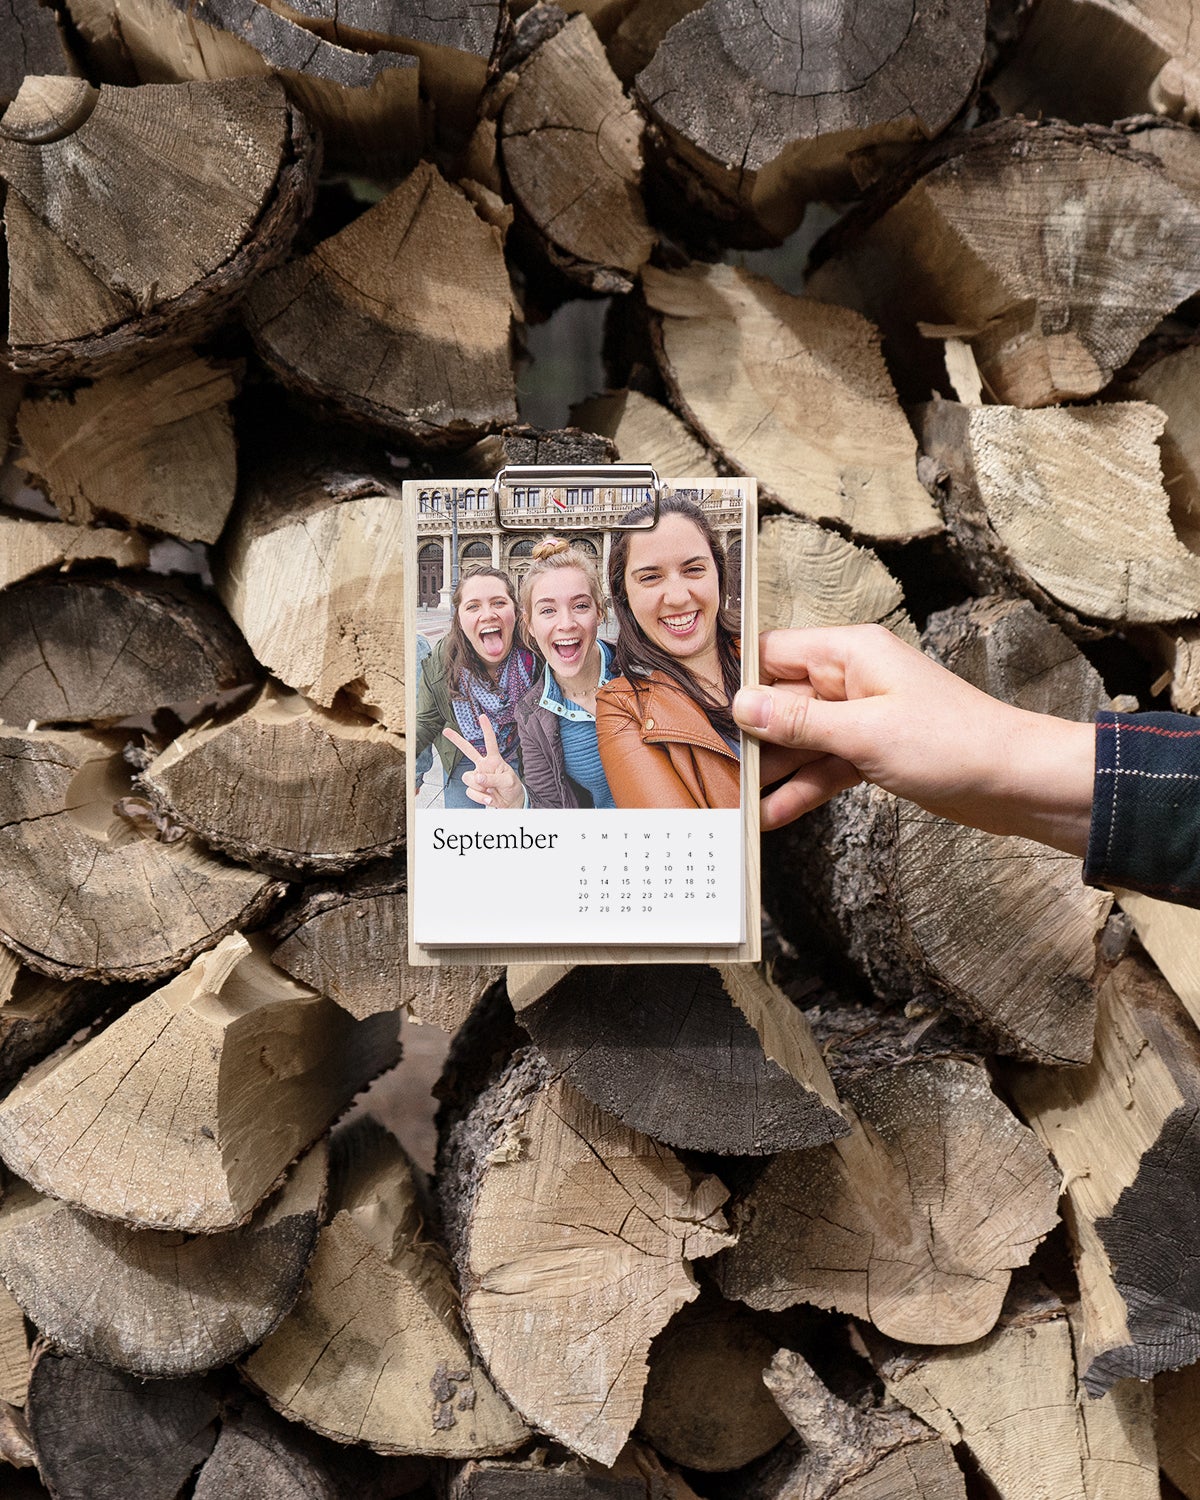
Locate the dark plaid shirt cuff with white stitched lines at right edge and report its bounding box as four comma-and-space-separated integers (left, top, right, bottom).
1083, 711, 1200, 906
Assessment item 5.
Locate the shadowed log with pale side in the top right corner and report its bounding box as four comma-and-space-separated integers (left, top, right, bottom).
989, 0, 1200, 125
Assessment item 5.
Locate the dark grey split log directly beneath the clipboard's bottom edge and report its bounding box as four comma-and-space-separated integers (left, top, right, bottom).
515, 965, 846, 1157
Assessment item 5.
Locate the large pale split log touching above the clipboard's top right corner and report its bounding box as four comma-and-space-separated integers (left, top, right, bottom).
642, 264, 942, 540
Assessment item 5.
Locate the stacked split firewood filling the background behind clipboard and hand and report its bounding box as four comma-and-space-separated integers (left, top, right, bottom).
0, 0, 1200, 1500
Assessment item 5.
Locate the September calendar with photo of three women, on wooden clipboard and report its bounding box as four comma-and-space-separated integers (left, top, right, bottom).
404, 465, 759, 963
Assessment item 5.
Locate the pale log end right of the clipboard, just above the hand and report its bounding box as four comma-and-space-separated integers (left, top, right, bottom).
759, 516, 917, 645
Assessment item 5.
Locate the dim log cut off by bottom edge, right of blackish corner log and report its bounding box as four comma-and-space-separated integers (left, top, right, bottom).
192, 1398, 429, 1500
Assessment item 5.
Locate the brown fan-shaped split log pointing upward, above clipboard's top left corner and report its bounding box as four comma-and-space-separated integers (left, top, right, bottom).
243, 162, 516, 447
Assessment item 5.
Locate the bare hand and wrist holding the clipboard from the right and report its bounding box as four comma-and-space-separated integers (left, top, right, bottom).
734, 626, 1095, 857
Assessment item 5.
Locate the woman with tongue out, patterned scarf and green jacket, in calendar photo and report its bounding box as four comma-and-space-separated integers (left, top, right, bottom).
413, 567, 534, 807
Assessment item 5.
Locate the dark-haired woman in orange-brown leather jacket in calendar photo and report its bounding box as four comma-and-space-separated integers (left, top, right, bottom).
596, 495, 741, 807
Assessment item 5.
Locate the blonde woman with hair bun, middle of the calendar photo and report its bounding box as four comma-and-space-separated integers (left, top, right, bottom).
453, 536, 615, 809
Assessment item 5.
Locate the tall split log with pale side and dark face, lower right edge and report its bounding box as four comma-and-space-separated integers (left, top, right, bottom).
1008, 959, 1200, 1397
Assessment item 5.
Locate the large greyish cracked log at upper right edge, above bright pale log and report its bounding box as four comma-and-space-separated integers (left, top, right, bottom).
806, 120, 1200, 407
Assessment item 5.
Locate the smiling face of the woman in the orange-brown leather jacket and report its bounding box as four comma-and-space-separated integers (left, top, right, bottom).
626, 515, 722, 669
